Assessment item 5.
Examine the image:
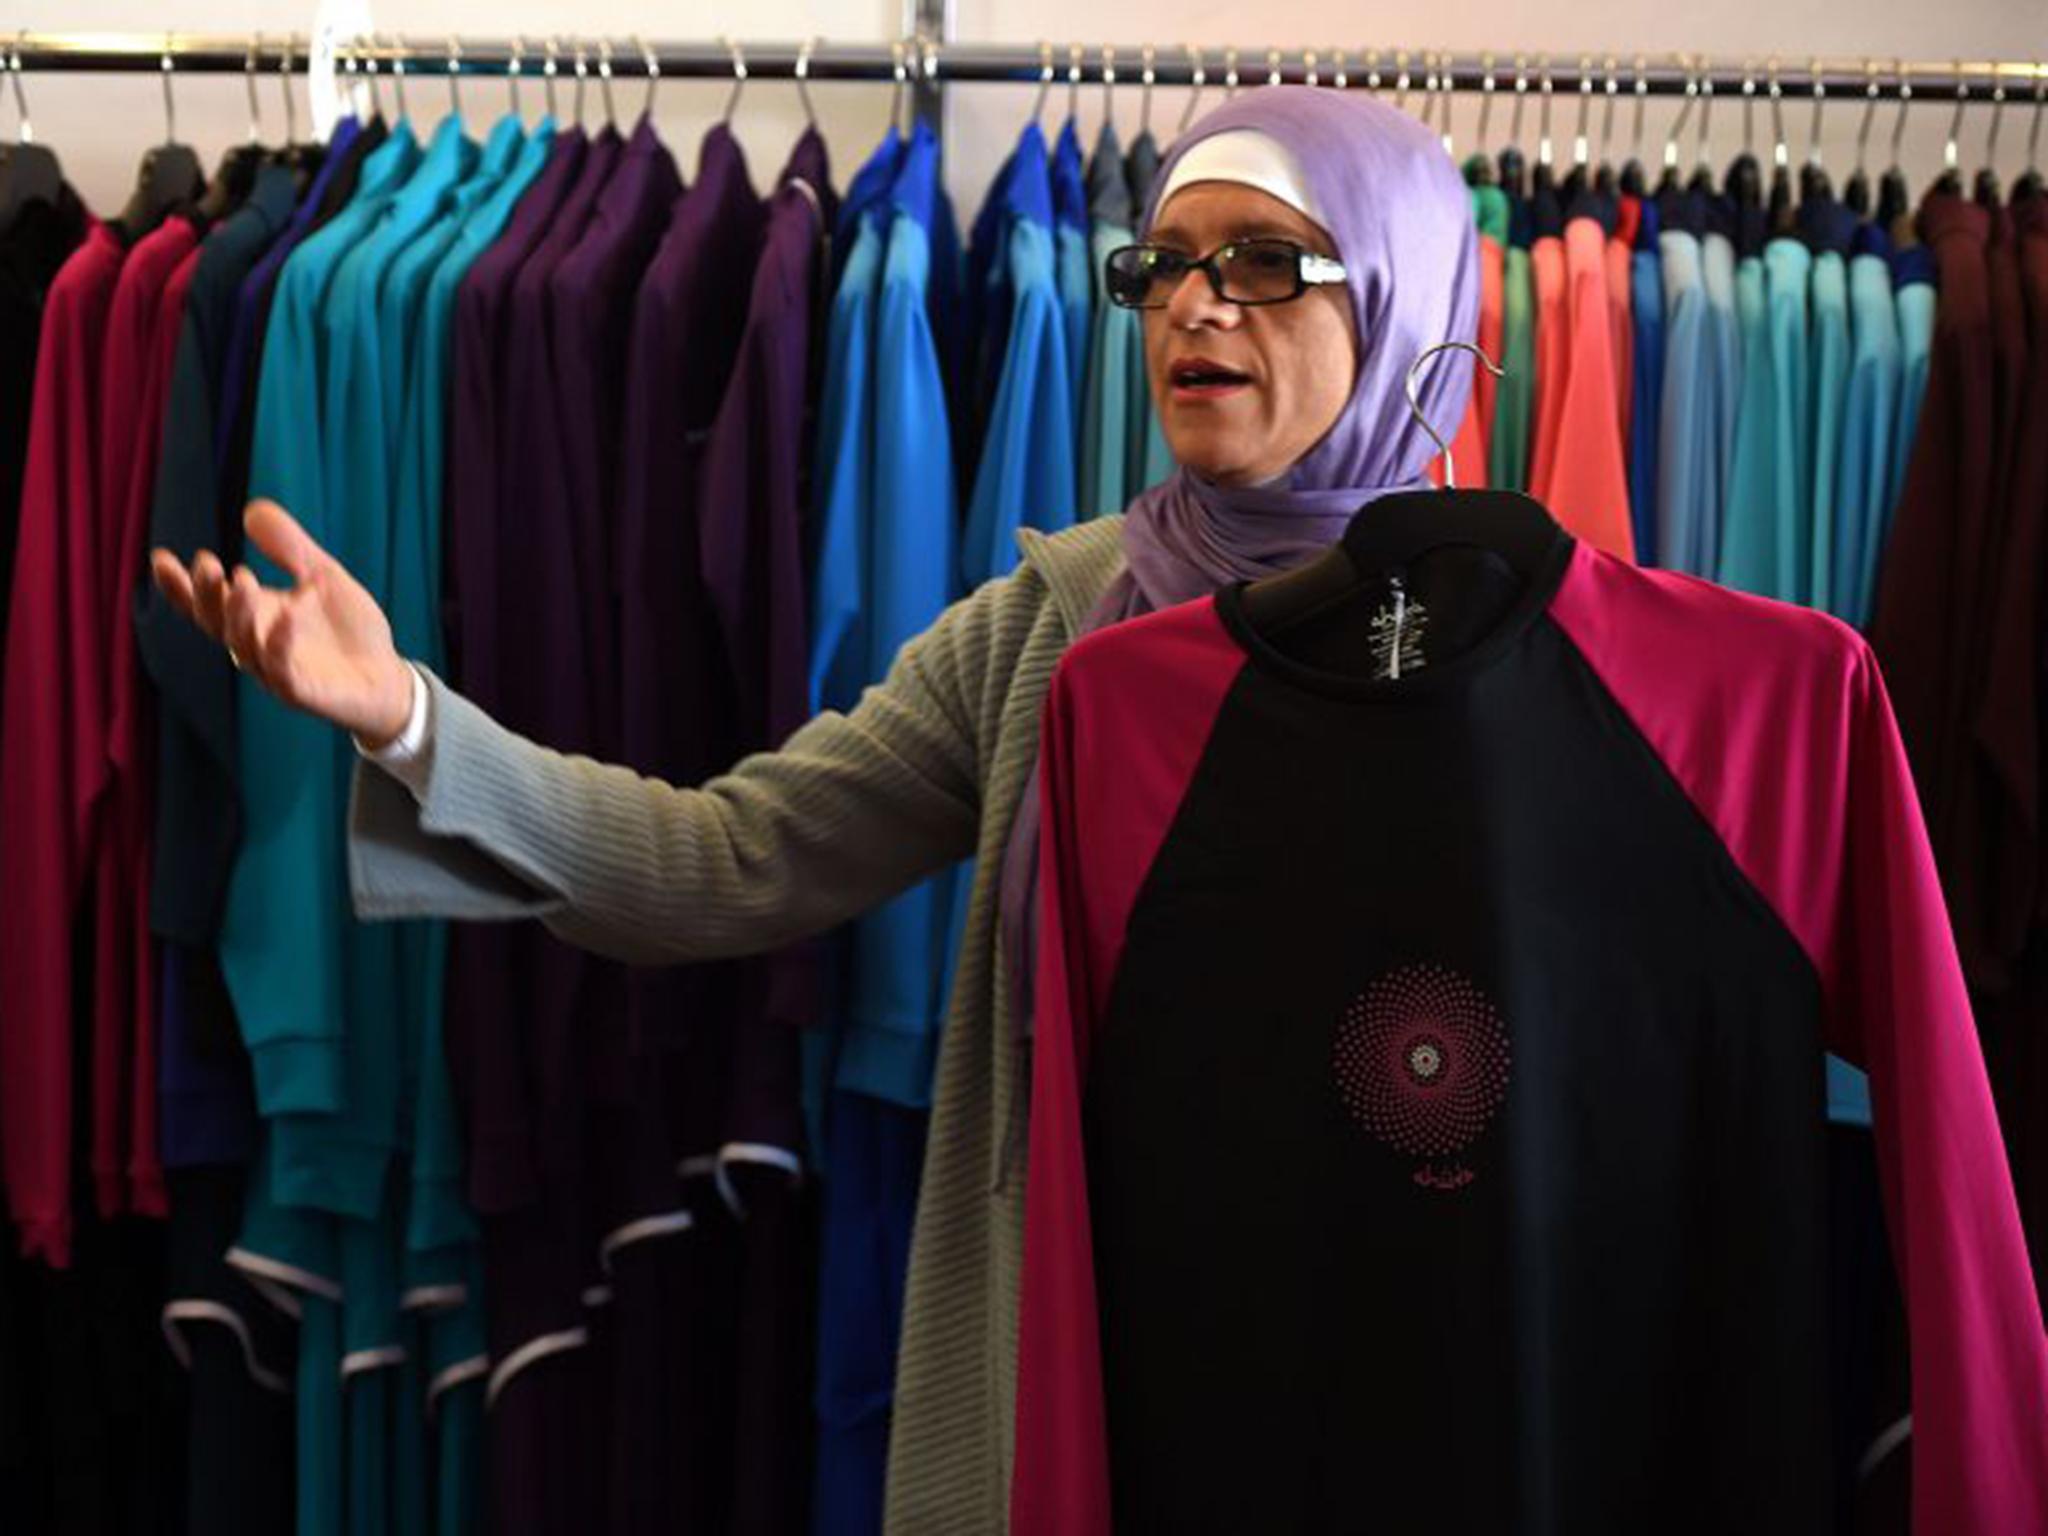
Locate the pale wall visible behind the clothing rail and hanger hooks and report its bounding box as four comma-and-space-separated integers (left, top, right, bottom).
0, 0, 2048, 234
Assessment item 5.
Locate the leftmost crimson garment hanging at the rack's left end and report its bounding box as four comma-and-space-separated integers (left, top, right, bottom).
0, 223, 127, 1266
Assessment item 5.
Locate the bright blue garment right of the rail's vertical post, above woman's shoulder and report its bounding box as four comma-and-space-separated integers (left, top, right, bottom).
961, 123, 1075, 588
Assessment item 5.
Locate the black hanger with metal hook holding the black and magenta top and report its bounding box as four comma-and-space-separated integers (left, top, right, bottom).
1241, 342, 1559, 651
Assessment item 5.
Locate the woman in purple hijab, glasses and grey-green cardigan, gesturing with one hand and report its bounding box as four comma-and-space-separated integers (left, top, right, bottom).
152, 86, 1479, 1532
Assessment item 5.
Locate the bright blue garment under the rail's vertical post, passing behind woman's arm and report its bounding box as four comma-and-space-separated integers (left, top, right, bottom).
829, 123, 958, 1108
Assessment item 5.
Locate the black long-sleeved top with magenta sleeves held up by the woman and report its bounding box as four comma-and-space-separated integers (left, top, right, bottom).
1012, 539, 2048, 1536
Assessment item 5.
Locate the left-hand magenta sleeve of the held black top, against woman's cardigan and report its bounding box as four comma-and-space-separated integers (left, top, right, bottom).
1010, 600, 1243, 1536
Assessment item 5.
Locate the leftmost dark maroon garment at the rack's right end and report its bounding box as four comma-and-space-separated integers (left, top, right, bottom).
1870, 193, 1999, 975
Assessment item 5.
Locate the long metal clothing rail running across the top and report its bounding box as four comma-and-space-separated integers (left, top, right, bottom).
0, 31, 2048, 104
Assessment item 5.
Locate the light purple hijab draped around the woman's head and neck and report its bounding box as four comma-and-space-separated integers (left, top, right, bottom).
1001, 86, 1479, 1032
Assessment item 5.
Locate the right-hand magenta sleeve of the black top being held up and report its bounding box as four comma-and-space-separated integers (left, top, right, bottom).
1550, 547, 2048, 1536
